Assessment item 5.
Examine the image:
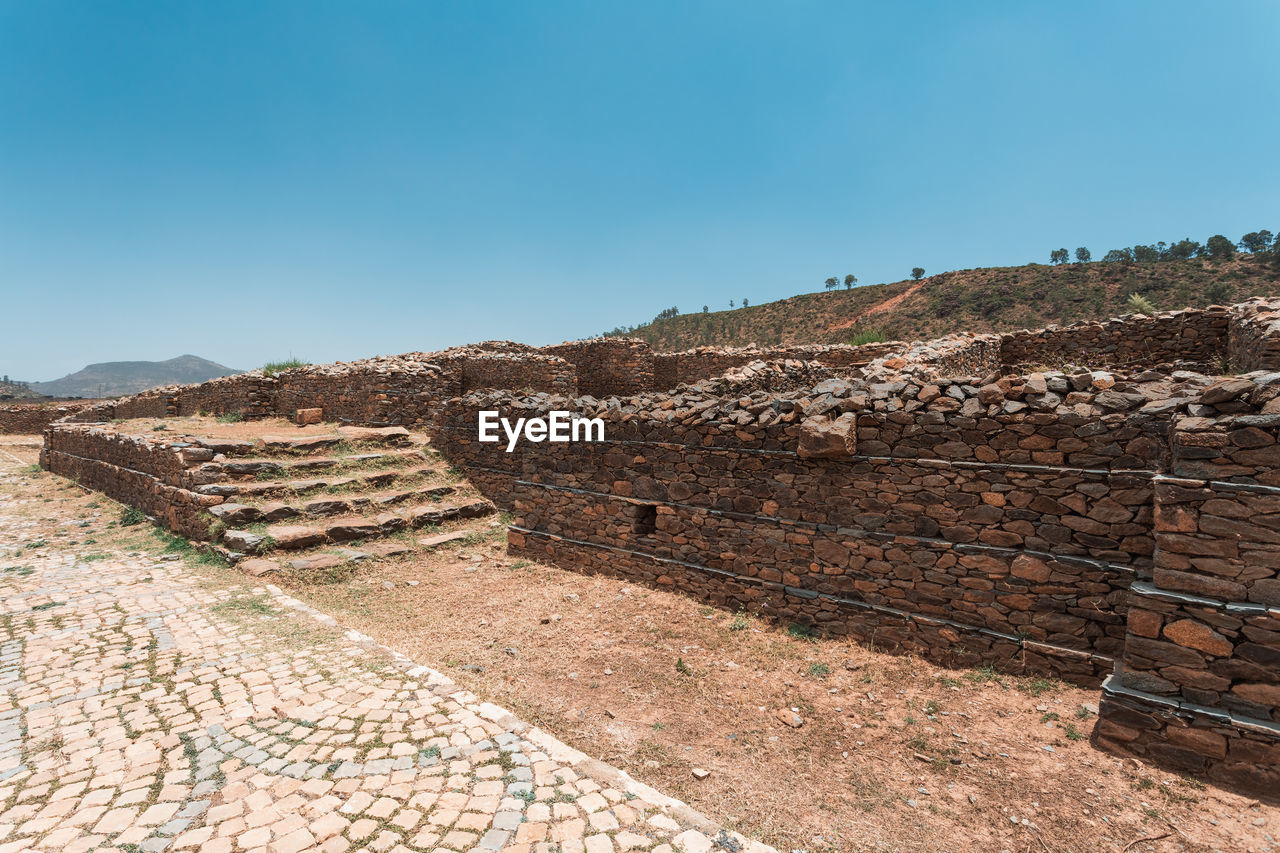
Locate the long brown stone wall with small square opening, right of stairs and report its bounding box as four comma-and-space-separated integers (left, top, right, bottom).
442, 361, 1198, 684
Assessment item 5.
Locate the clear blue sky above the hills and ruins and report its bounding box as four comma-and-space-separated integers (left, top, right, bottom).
0, 0, 1280, 380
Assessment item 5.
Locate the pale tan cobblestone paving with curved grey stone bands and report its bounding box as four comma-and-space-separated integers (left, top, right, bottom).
0, 455, 771, 853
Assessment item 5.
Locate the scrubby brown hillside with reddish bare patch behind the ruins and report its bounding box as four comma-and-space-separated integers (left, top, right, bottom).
628, 255, 1280, 351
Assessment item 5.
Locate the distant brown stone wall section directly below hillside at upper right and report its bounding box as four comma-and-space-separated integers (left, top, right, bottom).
1000, 306, 1229, 368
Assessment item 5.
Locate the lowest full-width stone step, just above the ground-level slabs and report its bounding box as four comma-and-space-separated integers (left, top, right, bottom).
221, 501, 494, 553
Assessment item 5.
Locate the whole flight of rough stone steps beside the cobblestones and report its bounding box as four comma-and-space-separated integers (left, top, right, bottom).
191, 427, 497, 575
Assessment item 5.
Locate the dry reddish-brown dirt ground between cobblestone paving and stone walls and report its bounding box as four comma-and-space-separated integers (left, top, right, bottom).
0, 437, 1280, 853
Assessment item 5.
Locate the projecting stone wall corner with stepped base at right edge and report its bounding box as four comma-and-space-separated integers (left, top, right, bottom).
1097, 373, 1280, 798
